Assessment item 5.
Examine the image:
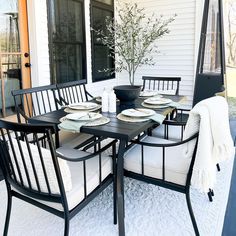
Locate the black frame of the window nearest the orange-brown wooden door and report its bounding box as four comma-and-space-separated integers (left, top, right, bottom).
47, 0, 87, 84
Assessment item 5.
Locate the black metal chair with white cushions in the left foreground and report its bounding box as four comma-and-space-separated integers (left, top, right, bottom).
0, 121, 117, 236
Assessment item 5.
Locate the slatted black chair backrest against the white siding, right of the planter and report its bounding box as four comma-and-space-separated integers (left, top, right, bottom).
142, 76, 181, 95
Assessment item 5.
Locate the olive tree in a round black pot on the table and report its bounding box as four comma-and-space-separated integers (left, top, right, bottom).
94, 3, 175, 104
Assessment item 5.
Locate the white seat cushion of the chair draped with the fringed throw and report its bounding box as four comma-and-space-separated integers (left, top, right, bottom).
124, 136, 191, 185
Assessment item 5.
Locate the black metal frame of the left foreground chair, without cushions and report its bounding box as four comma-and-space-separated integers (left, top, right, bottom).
0, 121, 117, 236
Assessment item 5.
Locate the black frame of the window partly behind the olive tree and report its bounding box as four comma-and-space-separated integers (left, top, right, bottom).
90, 0, 115, 83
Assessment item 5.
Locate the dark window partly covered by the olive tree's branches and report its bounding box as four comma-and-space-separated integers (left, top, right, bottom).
91, 0, 114, 82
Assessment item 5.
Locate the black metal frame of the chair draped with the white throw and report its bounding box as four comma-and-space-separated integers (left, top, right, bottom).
124, 133, 200, 236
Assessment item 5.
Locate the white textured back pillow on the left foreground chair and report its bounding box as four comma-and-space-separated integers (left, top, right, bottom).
9, 138, 72, 194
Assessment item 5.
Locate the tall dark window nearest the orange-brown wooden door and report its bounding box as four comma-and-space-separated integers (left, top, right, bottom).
48, 0, 86, 83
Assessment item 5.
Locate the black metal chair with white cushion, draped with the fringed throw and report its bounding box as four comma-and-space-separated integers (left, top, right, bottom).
124, 133, 199, 235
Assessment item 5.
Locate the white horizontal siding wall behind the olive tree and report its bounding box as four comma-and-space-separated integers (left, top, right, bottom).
120, 0, 201, 104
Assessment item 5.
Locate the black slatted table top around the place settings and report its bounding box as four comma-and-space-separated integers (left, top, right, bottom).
29, 95, 185, 141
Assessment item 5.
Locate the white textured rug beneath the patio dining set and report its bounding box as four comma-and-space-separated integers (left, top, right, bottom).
0, 160, 233, 236
